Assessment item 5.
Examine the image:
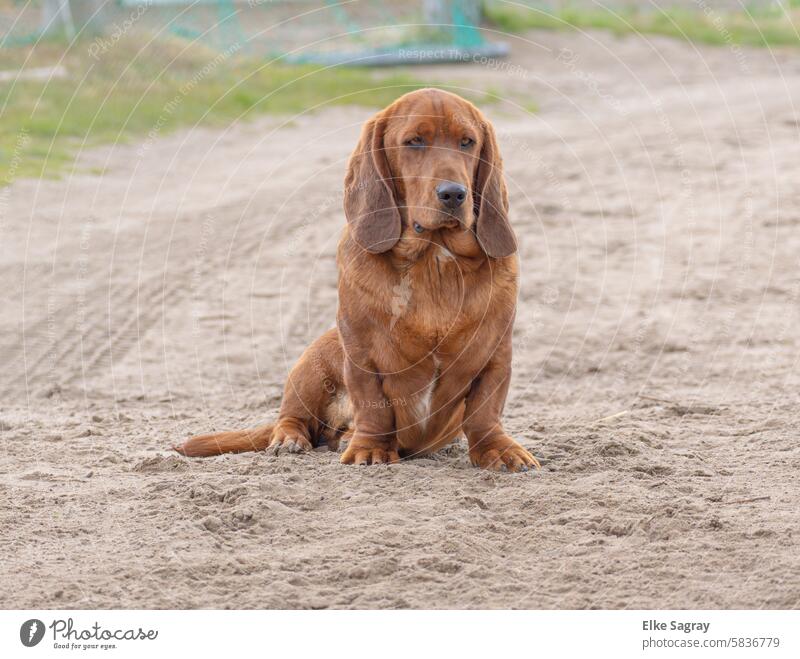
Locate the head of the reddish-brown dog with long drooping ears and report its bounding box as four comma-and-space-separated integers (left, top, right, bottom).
344, 89, 516, 258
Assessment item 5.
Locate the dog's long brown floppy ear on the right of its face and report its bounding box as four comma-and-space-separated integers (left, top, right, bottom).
475, 120, 517, 258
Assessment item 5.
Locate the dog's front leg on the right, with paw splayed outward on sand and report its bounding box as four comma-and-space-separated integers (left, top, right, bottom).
463, 333, 539, 471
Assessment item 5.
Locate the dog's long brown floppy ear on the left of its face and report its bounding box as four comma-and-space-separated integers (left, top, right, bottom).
344, 115, 402, 254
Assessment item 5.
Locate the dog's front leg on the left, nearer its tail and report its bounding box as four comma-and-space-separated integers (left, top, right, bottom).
341, 340, 400, 465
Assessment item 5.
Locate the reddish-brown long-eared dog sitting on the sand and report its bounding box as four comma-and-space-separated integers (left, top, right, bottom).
177, 89, 539, 471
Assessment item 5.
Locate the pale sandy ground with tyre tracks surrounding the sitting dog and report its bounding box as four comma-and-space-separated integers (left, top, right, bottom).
0, 33, 800, 608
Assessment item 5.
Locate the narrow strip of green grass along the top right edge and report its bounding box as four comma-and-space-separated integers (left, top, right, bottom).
484, 0, 800, 46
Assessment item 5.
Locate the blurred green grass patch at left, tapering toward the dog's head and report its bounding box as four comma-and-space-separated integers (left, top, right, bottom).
0, 41, 432, 186
